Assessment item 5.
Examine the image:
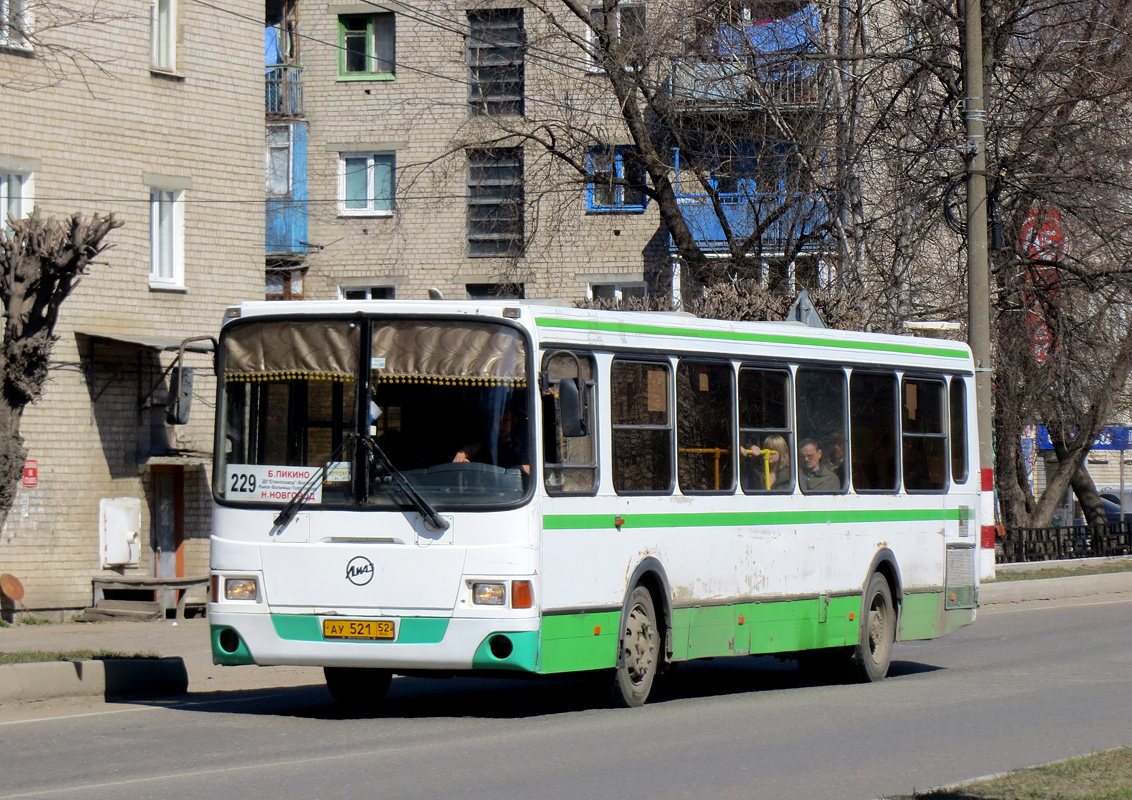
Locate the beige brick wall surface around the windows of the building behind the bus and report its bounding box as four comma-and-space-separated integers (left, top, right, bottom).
299, 0, 668, 301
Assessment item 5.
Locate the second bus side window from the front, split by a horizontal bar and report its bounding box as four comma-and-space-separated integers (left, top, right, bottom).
609, 360, 672, 494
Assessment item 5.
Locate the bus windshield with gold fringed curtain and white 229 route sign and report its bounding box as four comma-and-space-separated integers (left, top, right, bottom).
216, 317, 532, 509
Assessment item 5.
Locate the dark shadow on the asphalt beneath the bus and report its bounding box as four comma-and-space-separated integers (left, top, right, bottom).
136, 657, 941, 720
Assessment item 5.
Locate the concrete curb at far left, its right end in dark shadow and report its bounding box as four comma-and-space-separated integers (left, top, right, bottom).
0, 657, 189, 705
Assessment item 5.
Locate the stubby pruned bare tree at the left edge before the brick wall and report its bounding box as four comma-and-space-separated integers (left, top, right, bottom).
0, 209, 122, 527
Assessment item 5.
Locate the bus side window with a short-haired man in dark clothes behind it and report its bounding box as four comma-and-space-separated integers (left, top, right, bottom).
795, 367, 849, 493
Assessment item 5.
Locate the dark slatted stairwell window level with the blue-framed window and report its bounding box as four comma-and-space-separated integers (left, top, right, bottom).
468, 147, 524, 258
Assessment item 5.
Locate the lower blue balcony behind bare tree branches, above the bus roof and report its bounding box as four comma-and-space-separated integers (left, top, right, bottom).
677, 192, 829, 255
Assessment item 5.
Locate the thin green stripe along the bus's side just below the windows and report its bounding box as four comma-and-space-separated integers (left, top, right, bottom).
542, 508, 961, 531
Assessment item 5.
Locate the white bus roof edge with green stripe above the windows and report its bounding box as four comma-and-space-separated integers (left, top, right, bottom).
225, 300, 974, 372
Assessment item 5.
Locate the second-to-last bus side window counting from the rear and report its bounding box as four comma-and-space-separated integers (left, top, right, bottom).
902, 378, 947, 492
